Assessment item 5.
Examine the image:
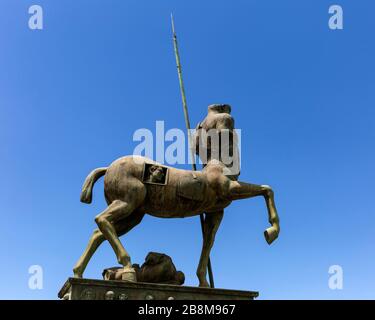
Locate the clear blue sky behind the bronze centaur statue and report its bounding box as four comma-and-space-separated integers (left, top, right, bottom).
0, 0, 375, 299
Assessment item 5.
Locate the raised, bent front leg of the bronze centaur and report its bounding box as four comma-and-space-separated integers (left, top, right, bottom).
229, 181, 280, 244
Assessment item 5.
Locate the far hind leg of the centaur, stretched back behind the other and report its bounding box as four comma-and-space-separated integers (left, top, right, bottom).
73, 211, 144, 278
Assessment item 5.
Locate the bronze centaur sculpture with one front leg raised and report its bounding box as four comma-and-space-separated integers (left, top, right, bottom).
73, 105, 280, 287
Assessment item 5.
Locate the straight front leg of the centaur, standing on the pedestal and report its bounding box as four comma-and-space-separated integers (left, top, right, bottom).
197, 210, 224, 287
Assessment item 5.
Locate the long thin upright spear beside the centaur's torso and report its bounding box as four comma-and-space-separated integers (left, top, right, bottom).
171, 14, 215, 288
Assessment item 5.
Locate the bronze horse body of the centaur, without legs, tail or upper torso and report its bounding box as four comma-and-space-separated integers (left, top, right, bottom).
104, 156, 231, 218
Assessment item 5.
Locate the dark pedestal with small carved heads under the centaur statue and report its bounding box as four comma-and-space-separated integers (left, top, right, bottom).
58, 278, 258, 300
